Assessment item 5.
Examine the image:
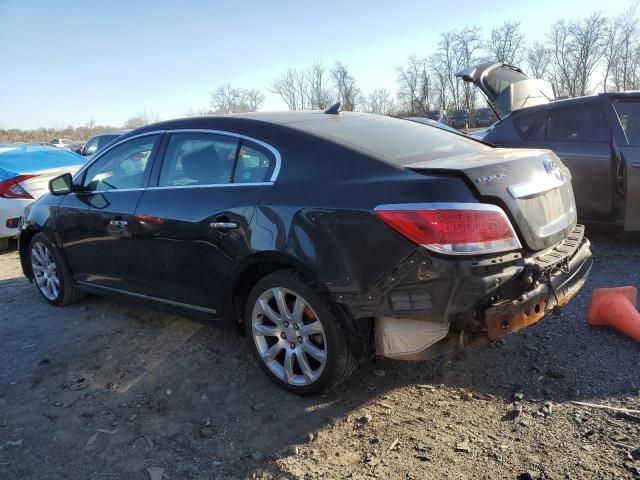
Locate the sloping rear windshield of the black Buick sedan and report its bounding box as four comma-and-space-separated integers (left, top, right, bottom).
291, 114, 491, 165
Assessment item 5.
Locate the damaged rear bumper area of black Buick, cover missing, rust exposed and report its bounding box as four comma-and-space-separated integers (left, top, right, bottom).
337, 225, 592, 360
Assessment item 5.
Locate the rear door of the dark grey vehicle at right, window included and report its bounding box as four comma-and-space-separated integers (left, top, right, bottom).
507, 103, 614, 221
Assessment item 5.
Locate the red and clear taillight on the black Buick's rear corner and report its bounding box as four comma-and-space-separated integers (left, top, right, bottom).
375, 203, 522, 255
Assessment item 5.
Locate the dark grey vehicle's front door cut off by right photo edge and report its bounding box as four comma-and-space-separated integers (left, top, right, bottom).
612, 94, 640, 232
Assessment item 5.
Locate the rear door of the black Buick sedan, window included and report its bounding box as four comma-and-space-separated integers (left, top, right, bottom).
132, 130, 279, 313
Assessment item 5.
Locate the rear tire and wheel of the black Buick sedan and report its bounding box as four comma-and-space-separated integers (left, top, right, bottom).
245, 270, 358, 395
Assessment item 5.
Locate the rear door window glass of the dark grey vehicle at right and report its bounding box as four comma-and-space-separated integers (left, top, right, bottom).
547, 104, 611, 142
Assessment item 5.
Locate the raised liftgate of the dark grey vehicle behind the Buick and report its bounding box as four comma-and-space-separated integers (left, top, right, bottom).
456, 62, 555, 117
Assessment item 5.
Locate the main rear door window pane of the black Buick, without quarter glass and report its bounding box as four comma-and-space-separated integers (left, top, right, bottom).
159, 132, 239, 187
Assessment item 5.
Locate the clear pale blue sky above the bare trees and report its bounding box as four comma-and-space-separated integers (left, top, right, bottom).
0, 0, 631, 129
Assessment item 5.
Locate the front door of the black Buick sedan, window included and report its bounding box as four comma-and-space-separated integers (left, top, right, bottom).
56, 133, 162, 292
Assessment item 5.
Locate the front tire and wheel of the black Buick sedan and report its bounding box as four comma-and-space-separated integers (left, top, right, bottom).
29, 233, 85, 307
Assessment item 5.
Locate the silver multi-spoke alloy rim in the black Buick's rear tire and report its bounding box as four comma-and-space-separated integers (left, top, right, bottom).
251, 287, 327, 386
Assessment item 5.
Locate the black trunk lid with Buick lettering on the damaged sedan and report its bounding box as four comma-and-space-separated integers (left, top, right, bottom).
407, 148, 577, 251
